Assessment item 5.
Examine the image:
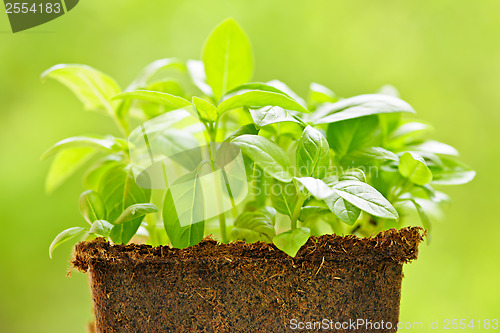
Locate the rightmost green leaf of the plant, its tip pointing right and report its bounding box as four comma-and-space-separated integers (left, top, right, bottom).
430, 157, 476, 185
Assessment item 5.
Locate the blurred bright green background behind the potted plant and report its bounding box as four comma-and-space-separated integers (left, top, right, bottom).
0, 0, 500, 333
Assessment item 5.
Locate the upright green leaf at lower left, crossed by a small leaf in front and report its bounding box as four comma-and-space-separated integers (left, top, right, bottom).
97, 164, 151, 244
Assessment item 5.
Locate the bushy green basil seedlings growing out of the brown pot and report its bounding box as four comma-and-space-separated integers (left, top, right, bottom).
42, 19, 475, 256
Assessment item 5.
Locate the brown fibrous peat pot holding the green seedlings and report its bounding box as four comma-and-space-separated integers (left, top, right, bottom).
73, 227, 424, 333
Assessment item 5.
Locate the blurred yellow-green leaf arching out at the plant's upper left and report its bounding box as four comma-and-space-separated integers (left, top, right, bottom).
42, 64, 120, 114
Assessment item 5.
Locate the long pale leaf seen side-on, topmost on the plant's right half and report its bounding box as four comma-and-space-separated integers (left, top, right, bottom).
314, 94, 415, 124
